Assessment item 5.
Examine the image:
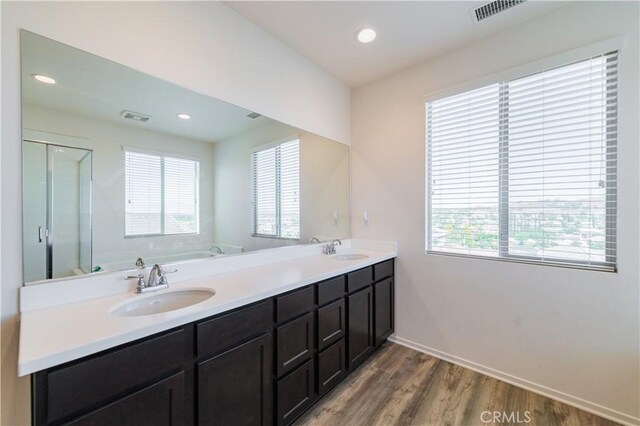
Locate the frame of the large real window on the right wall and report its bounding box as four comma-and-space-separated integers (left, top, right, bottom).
423, 45, 623, 273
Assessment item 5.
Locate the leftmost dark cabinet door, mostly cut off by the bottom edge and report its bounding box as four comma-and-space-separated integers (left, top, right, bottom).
66, 372, 185, 426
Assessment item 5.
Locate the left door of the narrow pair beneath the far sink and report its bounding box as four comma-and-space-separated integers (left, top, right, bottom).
347, 287, 373, 370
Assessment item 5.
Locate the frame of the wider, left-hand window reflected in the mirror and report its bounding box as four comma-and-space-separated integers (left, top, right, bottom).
122, 146, 200, 239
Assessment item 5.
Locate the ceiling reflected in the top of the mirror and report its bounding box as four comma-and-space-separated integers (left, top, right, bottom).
21, 31, 272, 142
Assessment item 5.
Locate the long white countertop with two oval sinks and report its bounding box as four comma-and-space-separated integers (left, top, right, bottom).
18, 243, 397, 376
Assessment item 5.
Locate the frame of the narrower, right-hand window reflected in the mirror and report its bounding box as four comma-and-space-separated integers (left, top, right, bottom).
251, 138, 302, 241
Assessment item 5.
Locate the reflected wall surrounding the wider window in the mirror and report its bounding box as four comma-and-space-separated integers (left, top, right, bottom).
22, 105, 214, 267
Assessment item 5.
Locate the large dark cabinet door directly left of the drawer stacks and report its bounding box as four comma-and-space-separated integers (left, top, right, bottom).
197, 334, 273, 426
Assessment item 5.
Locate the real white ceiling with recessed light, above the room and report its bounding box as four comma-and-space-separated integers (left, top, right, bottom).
225, 0, 569, 87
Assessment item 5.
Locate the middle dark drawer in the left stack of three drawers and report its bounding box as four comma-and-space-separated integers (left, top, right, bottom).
276, 313, 313, 377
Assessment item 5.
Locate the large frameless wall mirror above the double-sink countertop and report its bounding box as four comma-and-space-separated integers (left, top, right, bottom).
21, 31, 350, 283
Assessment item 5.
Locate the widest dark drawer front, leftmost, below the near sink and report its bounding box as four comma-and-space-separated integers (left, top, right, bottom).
46, 329, 186, 422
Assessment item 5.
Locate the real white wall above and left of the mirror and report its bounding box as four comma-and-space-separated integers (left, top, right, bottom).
0, 1, 350, 425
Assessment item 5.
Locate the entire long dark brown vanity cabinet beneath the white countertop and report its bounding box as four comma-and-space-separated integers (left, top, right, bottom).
32, 259, 394, 426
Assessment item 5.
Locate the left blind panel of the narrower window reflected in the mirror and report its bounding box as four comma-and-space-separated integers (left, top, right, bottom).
252, 147, 278, 237
